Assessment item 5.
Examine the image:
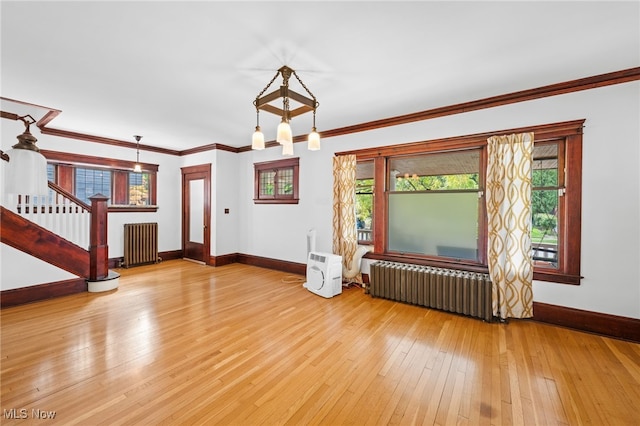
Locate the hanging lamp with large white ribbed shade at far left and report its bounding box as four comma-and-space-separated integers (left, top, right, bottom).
3, 115, 49, 195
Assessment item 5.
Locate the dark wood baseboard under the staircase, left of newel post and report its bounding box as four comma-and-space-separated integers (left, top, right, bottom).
0, 278, 87, 309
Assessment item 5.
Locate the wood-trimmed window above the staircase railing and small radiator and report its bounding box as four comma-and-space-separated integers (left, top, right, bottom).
41, 150, 158, 212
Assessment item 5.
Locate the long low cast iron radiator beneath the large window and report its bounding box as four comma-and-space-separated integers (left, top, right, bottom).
369, 261, 493, 322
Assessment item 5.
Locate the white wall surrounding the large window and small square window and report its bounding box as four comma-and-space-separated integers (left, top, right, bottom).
232, 82, 640, 318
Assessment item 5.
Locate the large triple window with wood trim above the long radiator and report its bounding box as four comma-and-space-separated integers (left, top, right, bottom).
344, 120, 584, 284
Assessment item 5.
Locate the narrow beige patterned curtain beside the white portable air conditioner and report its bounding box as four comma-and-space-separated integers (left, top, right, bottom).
333, 155, 358, 268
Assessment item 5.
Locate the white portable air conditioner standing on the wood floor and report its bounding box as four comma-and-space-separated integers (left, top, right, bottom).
303, 251, 342, 299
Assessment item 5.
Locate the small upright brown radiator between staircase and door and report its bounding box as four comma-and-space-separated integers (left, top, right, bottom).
122, 222, 161, 268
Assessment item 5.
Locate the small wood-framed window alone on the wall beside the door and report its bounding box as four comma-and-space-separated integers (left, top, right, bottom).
253, 158, 299, 204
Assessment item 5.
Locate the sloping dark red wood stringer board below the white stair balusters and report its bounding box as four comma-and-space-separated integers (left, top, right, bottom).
0, 206, 90, 278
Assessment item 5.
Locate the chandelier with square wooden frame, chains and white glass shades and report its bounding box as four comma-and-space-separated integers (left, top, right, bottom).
251, 65, 320, 155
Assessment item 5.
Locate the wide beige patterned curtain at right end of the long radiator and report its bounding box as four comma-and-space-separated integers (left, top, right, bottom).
486, 133, 533, 319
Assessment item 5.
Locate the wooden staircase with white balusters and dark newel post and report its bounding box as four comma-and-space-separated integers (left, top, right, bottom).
0, 182, 119, 307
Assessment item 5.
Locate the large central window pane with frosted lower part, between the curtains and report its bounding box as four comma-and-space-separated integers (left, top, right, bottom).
387, 148, 481, 262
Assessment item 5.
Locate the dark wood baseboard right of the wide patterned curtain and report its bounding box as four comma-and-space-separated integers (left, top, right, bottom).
533, 302, 640, 343
